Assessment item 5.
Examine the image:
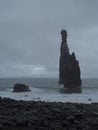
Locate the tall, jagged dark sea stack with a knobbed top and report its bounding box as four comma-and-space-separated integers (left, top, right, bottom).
59, 30, 81, 88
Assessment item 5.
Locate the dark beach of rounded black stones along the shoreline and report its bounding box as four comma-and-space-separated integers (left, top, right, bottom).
0, 98, 98, 130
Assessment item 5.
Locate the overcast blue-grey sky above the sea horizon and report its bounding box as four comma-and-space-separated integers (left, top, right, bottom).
0, 0, 98, 77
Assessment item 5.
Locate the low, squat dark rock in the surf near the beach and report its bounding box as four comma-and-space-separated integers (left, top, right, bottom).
13, 84, 31, 92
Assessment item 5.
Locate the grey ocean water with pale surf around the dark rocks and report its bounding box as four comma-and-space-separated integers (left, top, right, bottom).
0, 78, 98, 103
